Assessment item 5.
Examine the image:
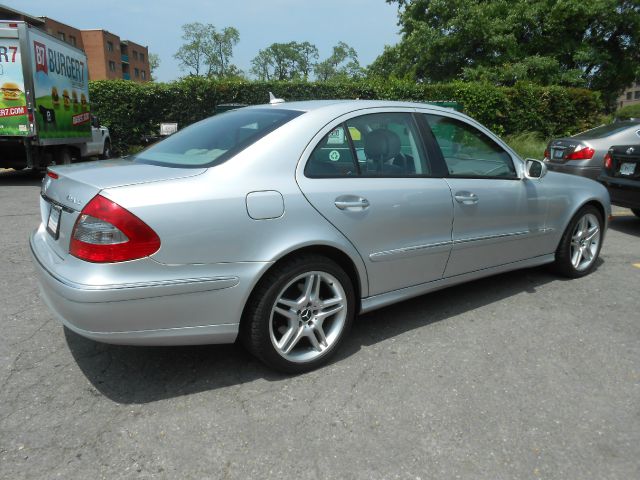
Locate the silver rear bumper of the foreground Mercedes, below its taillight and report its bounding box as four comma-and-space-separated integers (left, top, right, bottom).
30, 229, 268, 345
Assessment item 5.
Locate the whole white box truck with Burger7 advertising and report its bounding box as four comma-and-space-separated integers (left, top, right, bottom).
0, 20, 111, 169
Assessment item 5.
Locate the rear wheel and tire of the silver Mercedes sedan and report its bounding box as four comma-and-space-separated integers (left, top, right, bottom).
240, 255, 355, 373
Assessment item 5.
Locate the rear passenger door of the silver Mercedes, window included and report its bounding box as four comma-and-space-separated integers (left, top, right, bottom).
297, 109, 453, 295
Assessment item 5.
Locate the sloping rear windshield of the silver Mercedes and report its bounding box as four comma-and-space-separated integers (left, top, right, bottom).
131, 108, 303, 168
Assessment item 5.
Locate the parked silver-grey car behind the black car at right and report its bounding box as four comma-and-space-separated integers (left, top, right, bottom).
544, 120, 640, 180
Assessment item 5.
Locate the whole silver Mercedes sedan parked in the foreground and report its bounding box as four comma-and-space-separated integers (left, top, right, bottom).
30, 100, 611, 372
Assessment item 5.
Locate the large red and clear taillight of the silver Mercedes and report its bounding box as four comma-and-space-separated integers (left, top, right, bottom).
69, 195, 160, 263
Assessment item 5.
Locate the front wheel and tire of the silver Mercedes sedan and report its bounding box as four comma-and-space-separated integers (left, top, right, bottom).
553, 205, 603, 278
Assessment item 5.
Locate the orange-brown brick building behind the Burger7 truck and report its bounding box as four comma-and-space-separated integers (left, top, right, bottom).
0, 5, 151, 82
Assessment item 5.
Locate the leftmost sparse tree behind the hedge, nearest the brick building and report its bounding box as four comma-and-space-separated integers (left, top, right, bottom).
174, 22, 242, 78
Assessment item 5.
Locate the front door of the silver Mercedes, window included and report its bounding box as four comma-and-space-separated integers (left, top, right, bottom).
424, 113, 549, 277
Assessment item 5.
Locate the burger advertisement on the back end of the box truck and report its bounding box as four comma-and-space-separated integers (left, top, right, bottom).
0, 38, 29, 136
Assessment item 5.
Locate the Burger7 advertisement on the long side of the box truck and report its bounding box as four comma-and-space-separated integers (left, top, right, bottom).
30, 30, 91, 139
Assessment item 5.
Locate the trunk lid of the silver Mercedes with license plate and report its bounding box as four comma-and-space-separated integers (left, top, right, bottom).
40, 159, 206, 257
